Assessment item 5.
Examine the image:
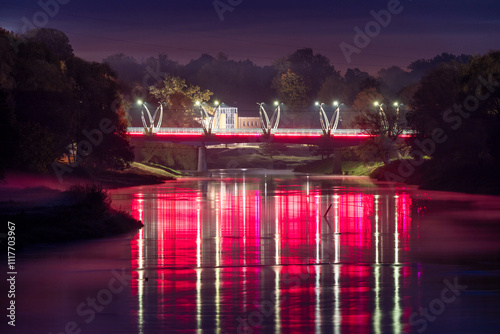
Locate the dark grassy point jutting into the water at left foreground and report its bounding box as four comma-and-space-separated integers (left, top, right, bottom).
0, 184, 143, 248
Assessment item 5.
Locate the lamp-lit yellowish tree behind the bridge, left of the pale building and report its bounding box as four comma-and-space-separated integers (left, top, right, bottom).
150, 76, 213, 127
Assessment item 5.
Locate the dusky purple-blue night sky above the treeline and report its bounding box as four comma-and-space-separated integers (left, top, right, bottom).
0, 0, 500, 73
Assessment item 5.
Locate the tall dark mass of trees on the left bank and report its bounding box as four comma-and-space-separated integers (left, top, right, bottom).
0, 29, 133, 177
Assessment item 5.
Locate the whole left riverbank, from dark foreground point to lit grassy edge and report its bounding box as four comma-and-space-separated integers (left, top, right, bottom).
0, 162, 180, 248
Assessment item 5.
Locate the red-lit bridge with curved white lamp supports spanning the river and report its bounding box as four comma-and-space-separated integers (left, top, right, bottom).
127, 102, 413, 172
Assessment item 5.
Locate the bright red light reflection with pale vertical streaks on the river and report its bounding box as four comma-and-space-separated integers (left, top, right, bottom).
132, 179, 412, 333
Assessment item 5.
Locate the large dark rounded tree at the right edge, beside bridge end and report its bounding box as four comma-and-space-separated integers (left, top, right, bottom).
409, 51, 500, 168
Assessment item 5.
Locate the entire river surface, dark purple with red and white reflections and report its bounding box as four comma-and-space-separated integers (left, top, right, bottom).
2, 171, 500, 334
